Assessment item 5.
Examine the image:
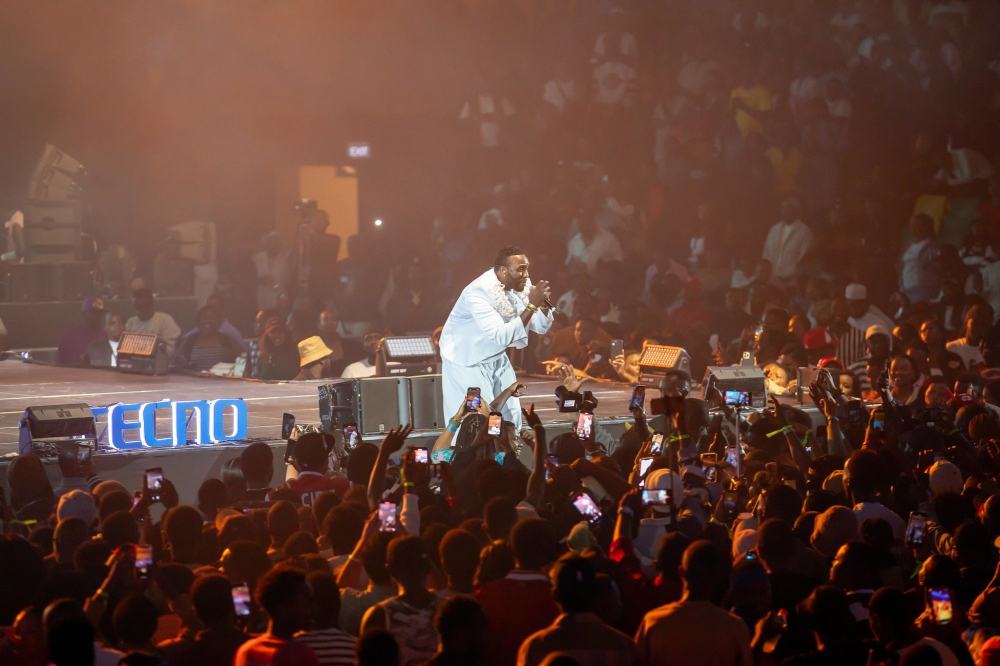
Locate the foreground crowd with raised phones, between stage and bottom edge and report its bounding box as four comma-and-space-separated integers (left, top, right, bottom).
7, 348, 1000, 666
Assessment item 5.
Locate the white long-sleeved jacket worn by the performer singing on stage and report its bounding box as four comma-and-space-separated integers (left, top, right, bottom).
440, 268, 552, 366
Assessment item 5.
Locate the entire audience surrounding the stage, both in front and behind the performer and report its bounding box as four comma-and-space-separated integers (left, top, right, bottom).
9, 0, 1000, 666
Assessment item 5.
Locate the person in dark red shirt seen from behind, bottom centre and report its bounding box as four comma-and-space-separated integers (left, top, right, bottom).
476, 518, 559, 666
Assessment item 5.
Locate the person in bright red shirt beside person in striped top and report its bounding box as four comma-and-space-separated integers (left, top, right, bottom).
233, 565, 319, 666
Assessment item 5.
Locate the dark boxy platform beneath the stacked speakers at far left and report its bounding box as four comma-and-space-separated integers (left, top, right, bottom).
3, 261, 94, 302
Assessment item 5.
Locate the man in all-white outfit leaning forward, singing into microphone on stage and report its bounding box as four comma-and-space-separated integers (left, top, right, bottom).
440, 247, 552, 430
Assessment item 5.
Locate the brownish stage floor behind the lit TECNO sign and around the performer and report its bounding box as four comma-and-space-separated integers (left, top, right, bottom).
0, 359, 631, 455
